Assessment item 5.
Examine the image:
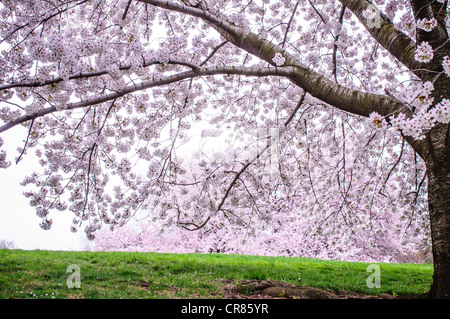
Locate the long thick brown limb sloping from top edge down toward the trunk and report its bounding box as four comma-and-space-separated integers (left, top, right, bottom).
140, 0, 415, 122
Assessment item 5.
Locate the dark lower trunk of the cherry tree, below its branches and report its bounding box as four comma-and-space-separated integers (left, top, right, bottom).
425, 125, 450, 299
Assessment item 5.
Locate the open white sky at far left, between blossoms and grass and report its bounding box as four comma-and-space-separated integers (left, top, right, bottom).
0, 127, 87, 250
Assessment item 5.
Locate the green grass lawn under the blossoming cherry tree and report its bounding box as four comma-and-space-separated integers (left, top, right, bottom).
0, 250, 433, 299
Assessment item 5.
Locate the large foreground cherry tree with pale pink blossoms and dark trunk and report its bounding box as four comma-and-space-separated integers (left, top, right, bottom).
0, 0, 450, 298
